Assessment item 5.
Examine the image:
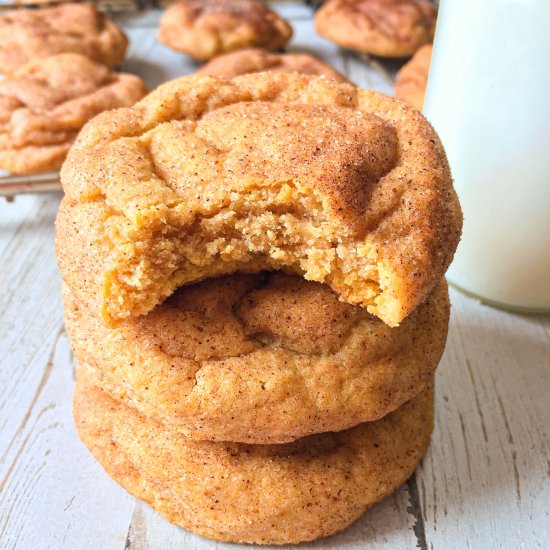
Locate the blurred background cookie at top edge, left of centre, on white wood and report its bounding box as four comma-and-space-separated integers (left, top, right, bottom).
158, 0, 292, 60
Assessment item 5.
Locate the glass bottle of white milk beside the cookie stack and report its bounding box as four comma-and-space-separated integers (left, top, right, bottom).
424, 0, 550, 310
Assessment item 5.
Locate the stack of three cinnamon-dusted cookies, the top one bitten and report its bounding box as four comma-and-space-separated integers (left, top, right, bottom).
56, 73, 461, 544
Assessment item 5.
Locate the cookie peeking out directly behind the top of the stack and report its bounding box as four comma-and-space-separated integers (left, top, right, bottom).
196, 49, 349, 82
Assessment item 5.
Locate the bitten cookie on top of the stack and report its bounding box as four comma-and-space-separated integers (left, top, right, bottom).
56, 73, 462, 326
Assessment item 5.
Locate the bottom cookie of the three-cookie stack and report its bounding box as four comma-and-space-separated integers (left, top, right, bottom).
74, 373, 433, 544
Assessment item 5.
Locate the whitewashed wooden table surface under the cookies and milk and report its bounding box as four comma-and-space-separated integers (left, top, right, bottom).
0, 6, 550, 550
